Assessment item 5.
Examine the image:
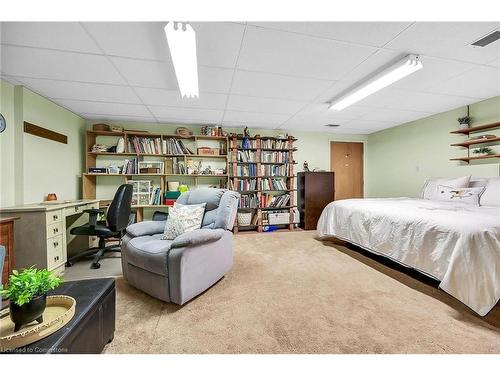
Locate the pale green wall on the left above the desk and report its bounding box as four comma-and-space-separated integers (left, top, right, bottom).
0, 81, 86, 206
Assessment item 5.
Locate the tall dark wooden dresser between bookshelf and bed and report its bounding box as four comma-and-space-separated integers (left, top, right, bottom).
297, 172, 335, 230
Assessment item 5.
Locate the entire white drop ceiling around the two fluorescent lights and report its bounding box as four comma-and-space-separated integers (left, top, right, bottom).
0, 22, 500, 134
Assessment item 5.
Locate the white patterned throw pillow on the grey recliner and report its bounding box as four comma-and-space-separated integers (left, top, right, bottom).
161, 202, 207, 240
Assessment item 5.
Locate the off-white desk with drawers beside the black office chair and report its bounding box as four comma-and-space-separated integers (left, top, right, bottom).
0, 199, 99, 274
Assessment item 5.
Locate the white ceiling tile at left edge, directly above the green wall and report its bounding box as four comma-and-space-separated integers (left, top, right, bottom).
1, 46, 125, 84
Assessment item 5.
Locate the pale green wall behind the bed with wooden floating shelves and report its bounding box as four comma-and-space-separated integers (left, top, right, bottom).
365, 96, 500, 197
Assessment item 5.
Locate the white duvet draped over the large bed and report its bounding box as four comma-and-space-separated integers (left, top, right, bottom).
317, 198, 500, 316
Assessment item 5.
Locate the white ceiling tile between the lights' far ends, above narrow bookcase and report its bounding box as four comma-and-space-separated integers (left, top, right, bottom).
227, 95, 307, 115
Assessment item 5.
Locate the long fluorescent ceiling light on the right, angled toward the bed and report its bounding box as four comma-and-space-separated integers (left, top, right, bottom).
330, 55, 423, 111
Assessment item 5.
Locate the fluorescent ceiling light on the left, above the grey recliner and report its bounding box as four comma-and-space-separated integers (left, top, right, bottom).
165, 22, 200, 98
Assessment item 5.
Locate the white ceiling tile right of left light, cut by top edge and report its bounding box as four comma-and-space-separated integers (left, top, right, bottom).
191, 22, 245, 69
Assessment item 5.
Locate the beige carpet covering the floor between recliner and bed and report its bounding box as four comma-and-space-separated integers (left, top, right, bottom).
105, 232, 500, 353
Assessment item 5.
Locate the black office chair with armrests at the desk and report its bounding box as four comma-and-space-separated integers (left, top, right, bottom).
66, 184, 133, 269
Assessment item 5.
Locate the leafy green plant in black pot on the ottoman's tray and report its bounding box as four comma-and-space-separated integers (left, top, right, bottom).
0, 267, 62, 332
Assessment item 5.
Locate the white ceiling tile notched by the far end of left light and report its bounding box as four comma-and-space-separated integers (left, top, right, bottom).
135, 87, 227, 109
